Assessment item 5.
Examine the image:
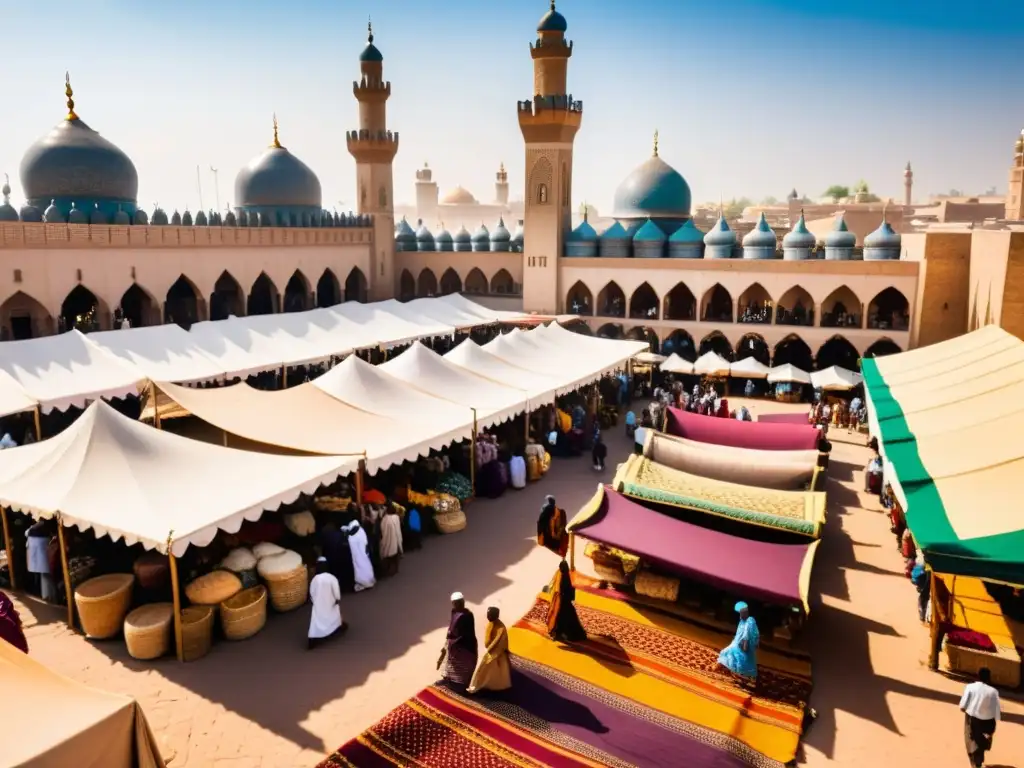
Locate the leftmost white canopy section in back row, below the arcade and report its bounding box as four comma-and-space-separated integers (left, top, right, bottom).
0, 331, 145, 413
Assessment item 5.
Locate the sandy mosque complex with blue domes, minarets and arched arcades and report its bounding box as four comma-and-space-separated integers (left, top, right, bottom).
0, 1, 1024, 368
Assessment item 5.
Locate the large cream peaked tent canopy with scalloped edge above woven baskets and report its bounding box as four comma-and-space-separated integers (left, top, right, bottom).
0, 399, 357, 556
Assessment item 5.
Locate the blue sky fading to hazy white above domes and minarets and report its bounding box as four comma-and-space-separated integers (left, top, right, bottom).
0, 0, 1024, 217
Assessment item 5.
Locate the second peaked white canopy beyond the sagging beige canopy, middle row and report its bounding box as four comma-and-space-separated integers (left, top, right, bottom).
380, 343, 528, 429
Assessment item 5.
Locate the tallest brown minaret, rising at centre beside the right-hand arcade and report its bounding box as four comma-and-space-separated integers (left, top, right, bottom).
518, 0, 583, 313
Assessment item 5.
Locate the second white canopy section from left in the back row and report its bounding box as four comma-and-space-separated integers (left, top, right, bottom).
86, 324, 225, 384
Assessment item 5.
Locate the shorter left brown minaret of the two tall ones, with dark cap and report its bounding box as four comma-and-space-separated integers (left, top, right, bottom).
345, 24, 398, 300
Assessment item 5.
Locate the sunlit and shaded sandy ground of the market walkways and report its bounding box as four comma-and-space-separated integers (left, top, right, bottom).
9, 401, 1024, 768
